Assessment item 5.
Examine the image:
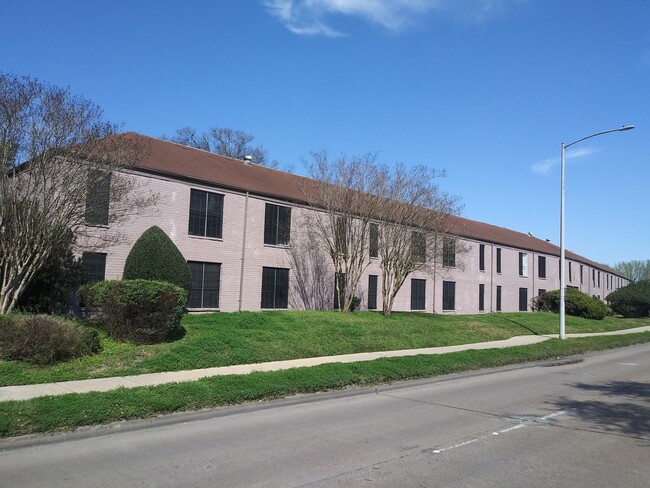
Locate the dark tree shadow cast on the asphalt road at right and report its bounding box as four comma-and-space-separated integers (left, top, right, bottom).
553, 381, 650, 437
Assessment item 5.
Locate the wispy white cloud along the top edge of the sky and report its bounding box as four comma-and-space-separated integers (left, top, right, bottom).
262, 0, 527, 37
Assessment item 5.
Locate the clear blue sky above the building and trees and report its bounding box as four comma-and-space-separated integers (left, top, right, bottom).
0, 0, 650, 264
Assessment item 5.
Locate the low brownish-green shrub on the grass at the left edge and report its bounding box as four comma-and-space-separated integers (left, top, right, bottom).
0, 315, 101, 365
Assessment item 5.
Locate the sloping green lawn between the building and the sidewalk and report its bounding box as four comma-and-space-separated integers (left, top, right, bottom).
0, 311, 650, 386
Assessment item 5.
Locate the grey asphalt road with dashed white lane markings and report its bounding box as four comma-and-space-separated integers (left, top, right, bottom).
0, 345, 650, 488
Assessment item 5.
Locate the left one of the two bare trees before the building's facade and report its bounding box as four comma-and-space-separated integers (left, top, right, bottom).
302, 151, 379, 311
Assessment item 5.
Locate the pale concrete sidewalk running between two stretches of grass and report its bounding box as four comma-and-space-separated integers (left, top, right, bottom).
0, 326, 650, 402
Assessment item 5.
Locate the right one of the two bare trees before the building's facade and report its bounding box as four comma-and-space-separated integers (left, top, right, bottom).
373, 164, 463, 316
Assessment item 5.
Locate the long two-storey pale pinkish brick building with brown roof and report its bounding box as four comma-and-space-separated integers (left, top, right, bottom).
83, 136, 628, 314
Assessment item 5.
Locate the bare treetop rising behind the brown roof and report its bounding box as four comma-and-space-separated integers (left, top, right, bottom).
162, 127, 278, 168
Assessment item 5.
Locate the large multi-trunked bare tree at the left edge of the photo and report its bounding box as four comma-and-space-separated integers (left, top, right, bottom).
0, 73, 155, 314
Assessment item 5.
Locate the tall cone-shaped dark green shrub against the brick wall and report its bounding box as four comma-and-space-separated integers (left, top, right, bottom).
123, 225, 192, 295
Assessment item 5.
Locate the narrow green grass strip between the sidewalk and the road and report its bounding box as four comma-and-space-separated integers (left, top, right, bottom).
0, 332, 650, 437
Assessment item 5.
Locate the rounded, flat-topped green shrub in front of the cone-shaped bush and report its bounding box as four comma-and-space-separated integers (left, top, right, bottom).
81, 280, 187, 344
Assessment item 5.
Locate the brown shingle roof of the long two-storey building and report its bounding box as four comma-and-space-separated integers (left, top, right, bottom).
128, 133, 618, 275
